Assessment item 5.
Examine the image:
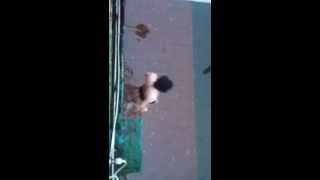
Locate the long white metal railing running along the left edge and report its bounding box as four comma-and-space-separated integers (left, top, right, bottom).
109, 0, 123, 180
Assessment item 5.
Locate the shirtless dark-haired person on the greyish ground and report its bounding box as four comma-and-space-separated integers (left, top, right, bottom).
126, 72, 173, 115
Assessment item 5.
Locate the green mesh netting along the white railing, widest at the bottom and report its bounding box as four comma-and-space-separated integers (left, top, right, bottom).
109, 0, 143, 178
